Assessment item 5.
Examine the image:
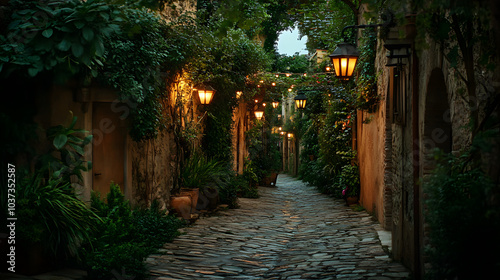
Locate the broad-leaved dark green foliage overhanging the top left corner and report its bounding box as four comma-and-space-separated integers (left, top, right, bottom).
0, 0, 119, 78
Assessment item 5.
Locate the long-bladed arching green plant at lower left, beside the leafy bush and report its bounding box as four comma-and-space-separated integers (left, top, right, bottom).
16, 172, 100, 259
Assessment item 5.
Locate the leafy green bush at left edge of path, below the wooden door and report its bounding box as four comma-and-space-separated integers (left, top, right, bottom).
84, 184, 183, 279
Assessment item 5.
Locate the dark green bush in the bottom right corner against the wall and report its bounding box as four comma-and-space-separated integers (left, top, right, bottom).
424, 149, 500, 279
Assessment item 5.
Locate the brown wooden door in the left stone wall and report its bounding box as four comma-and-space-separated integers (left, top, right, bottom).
92, 102, 127, 197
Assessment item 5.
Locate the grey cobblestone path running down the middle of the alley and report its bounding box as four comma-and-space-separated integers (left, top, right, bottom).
148, 174, 409, 280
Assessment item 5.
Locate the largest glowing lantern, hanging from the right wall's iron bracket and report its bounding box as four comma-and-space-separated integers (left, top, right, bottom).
329, 42, 359, 80
